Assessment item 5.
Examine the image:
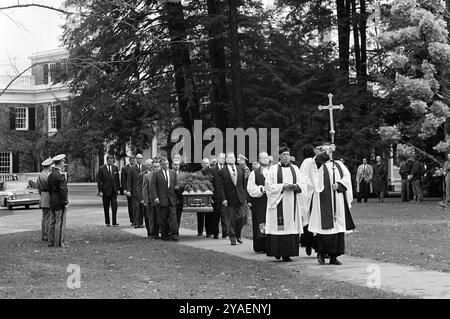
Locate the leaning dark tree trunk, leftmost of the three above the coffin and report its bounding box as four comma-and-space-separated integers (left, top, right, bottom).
165, 2, 199, 131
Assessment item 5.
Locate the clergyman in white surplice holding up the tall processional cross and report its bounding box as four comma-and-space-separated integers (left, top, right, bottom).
308, 144, 355, 265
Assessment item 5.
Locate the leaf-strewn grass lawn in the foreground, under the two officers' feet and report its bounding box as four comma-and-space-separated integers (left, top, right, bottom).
0, 226, 399, 299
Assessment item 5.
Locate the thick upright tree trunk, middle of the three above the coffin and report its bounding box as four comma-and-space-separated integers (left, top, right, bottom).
207, 0, 227, 131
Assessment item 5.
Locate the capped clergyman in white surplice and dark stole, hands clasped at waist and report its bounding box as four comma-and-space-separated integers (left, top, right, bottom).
265, 146, 306, 261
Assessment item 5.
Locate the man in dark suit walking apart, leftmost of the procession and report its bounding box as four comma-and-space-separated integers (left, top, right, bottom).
97, 155, 120, 227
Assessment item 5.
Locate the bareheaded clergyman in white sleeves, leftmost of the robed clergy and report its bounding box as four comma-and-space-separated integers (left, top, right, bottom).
247, 152, 269, 253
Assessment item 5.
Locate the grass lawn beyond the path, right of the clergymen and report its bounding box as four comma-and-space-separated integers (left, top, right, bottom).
182, 198, 450, 272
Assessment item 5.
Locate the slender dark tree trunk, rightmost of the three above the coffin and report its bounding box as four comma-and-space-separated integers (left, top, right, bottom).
228, 0, 245, 128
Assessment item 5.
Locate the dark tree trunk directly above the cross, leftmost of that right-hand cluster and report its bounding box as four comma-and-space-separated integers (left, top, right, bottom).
336, 0, 350, 81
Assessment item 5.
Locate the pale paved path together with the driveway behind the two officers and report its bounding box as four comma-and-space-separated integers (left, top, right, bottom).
0, 199, 450, 298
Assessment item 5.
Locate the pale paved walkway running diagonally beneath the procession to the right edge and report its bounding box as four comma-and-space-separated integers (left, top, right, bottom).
123, 228, 450, 299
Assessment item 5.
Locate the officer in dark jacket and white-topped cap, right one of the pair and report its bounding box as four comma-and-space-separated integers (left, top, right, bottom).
48, 154, 69, 248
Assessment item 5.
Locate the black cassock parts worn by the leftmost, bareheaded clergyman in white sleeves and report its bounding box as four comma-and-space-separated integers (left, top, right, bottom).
250, 168, 267, 252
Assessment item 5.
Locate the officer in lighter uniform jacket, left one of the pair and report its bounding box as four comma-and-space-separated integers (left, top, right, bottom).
37, 158, 53, 241
